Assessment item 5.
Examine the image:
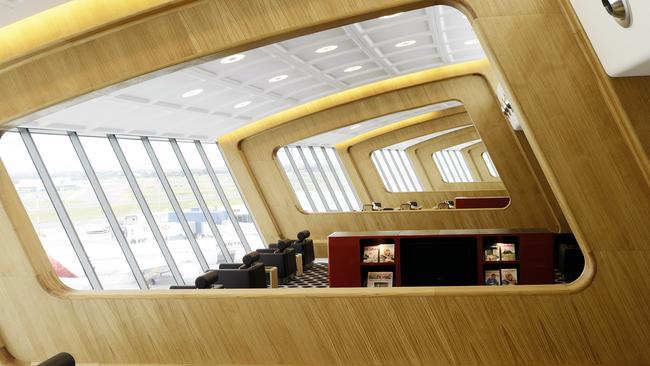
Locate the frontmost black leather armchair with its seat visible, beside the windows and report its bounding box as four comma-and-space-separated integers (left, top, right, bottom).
215, 252, 266, 288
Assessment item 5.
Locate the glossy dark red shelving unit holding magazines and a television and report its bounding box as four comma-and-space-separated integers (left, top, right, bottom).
328, 230, 554, 287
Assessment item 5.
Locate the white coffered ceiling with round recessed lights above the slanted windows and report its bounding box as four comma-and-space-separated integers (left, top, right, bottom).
17, 6, 484, 144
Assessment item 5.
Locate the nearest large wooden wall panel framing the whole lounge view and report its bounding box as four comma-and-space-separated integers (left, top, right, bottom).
0, 0, 650, 365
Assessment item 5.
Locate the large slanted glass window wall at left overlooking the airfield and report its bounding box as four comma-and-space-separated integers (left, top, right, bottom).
0, 129, 264, 289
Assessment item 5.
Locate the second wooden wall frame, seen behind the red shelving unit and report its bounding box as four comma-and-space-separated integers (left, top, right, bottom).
219, 70, 559, 241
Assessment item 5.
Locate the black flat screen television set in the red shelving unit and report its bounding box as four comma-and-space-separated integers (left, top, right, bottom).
400, 237, 477, 286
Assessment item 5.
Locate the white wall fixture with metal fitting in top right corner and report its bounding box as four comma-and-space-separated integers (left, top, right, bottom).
571, 0, 650, 77
